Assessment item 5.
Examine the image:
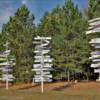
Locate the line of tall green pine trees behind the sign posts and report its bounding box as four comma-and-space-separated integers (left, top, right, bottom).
0, 0, 100, 83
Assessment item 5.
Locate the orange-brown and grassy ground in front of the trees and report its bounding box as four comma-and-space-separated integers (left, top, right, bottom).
0, 82, 100, 100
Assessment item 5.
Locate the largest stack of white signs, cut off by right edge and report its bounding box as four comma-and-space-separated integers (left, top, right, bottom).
86, 18, 100, 81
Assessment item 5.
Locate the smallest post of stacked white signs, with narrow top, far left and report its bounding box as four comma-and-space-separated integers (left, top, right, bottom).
0, 42, 15, 89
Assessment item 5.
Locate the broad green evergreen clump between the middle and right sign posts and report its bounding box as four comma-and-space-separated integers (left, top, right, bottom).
38, 0, 89, 81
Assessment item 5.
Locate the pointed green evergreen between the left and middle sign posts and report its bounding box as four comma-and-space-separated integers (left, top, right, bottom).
2, 5, 35, 82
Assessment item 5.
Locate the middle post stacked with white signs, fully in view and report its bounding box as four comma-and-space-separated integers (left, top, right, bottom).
33, 36, 53, 92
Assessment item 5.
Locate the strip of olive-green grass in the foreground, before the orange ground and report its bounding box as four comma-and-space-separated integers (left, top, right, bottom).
0, 89, 100, 100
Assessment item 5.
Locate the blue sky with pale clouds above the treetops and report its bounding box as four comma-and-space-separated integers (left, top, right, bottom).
0, 0, 88, 30
